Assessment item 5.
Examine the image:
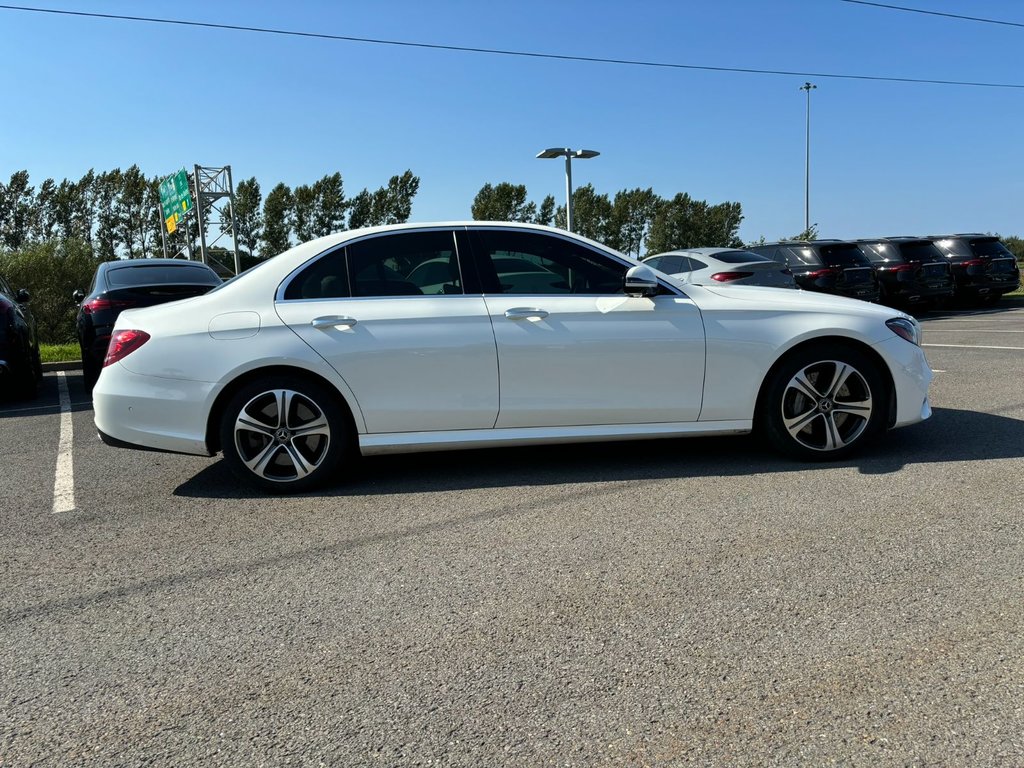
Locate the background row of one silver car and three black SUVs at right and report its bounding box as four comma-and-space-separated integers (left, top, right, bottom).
644, 233, 1020, 308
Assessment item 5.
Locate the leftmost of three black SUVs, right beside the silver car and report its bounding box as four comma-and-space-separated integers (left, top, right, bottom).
746, 240, 879, 301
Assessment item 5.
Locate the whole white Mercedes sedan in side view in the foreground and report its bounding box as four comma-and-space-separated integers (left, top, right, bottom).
93, 222, 932, 492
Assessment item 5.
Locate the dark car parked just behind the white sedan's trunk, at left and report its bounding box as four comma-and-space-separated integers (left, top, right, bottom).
75, 259, 221, 389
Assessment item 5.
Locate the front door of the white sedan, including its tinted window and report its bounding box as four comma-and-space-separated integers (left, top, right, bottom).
470, 227, 705, 434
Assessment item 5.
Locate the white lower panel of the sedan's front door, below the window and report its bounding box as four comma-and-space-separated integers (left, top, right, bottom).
485, 295, 705, 427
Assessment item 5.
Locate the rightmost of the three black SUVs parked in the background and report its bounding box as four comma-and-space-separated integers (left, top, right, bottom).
929, 234, 1021, 304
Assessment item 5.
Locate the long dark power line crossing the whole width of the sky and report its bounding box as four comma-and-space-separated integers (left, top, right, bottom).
6, 0, 1024, 89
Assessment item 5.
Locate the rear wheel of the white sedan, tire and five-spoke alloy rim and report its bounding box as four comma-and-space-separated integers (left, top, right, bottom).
220, 375, 355, 494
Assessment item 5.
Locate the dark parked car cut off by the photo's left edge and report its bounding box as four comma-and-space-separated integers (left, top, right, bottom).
0, 278, 43, 397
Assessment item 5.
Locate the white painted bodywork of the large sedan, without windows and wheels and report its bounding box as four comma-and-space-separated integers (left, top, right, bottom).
93, 222, 932, 462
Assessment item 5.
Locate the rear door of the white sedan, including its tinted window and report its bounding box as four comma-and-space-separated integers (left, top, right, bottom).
276, 228, 498, 433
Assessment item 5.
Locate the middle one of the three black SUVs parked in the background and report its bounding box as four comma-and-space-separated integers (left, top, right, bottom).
855, 238, 953, 307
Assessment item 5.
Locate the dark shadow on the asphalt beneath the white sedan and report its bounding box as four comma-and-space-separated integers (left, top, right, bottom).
174, 409, 1024, 499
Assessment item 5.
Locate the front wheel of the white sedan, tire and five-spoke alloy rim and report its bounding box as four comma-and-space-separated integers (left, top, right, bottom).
757, 345, 889, 461
